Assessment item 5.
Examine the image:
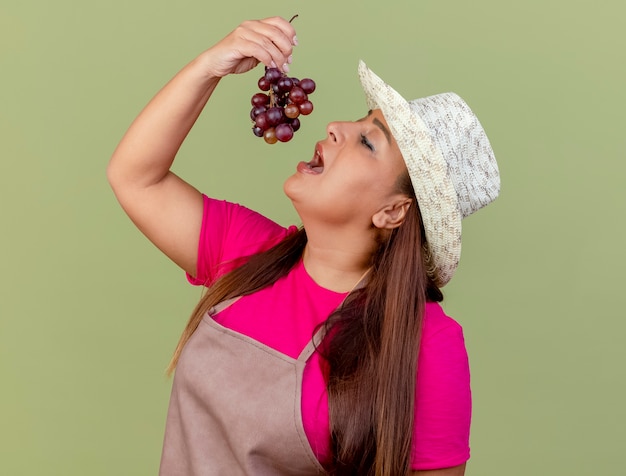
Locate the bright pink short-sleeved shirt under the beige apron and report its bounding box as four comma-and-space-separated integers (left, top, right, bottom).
188, 196, 471, 470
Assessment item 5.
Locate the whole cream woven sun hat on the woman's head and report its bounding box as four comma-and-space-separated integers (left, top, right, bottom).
358, 61, 500, 286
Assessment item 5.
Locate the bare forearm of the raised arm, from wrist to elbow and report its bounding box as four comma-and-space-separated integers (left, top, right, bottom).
107, 51, 220, 188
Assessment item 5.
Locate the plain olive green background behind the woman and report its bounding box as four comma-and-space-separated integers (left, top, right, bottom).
0, 0, 626, 476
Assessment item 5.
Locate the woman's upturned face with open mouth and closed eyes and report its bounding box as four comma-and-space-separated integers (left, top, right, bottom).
284, 109, 406, 227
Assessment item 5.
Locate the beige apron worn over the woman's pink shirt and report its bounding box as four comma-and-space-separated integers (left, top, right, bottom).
159, 298, 326, 476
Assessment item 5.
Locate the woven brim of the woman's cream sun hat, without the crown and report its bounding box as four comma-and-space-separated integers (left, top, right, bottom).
358, 61, 462, 286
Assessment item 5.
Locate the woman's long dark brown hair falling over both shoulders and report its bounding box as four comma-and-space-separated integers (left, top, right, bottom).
163, 174, 443, 476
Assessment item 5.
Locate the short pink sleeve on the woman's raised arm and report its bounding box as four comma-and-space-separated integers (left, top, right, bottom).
187, 195, 297, 285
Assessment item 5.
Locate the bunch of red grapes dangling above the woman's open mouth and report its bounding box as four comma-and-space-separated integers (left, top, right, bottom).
250, 68, 315, 144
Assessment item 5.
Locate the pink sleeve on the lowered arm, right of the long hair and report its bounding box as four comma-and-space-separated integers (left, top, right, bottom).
412, 306, 472, 470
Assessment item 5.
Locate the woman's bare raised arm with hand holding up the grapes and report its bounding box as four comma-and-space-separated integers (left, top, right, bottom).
107, 17, 295, 275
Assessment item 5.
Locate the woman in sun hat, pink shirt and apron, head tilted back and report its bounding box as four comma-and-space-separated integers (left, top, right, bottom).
108, 17, 500, 476
